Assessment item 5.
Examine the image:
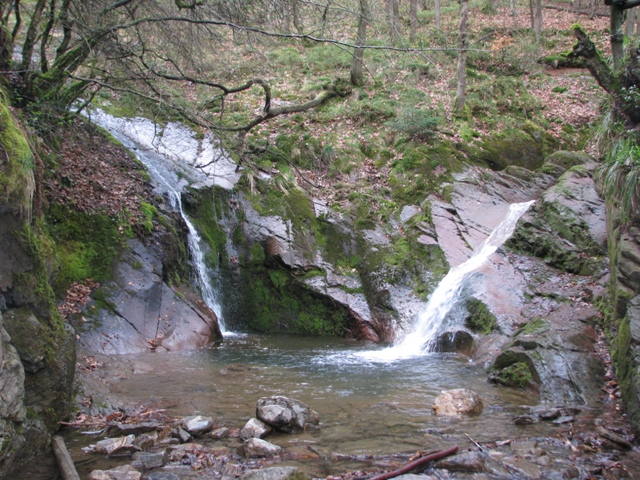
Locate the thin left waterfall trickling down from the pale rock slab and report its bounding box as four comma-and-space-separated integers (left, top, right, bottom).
89, 110, 229, 334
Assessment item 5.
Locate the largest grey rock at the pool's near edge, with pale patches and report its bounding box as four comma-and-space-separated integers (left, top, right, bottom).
256, 395, 320, 433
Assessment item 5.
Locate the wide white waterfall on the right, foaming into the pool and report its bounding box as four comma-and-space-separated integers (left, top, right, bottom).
356, 201, 534, 362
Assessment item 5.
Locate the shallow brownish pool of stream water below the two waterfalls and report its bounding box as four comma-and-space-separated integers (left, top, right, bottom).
63, 335, 568, 477
